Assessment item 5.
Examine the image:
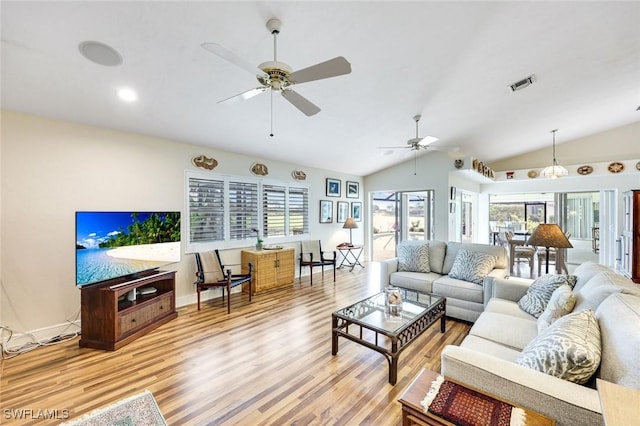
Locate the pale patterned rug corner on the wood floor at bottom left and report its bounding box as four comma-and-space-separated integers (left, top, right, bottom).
62, 390, 167, 426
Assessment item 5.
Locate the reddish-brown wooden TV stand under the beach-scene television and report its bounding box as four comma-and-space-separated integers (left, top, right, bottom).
79, 271, 178, 351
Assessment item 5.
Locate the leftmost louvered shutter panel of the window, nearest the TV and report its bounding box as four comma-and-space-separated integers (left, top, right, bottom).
188, 178, 224, 243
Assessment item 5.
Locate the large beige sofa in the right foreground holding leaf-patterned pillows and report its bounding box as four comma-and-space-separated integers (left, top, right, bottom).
442, 262, 640, 425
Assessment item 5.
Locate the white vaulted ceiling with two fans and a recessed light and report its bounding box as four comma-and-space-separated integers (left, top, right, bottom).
0, 1, 640, 175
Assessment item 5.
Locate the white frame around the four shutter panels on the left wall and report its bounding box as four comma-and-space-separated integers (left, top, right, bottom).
183, 170, 311, 253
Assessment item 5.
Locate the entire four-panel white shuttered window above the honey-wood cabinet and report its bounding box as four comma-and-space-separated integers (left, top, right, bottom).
185, 171, 309, 252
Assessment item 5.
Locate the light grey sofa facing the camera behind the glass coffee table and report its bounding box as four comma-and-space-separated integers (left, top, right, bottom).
379, 240, 509, 322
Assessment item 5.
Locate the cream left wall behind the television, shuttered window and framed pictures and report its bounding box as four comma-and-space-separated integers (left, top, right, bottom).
0, 111, 364, 337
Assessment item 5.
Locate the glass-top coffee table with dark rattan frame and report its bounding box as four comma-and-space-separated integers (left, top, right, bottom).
331, 289, 446, 385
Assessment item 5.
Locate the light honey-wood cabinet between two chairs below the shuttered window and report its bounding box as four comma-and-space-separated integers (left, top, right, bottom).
241, 248, 295, 294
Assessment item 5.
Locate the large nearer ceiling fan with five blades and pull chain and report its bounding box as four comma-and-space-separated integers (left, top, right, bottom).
201, 19, 351, 136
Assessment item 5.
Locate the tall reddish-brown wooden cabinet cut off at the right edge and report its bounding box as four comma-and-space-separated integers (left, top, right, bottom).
622, 190, 640, 284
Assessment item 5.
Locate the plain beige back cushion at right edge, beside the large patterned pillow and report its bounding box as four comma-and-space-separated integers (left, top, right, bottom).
596, 294, 640, 389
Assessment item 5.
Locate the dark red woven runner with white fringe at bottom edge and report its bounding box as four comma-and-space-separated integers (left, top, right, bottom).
421, 375, 526, 426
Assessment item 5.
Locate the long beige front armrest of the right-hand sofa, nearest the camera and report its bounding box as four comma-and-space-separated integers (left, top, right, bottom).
442, 345, 603, 425
